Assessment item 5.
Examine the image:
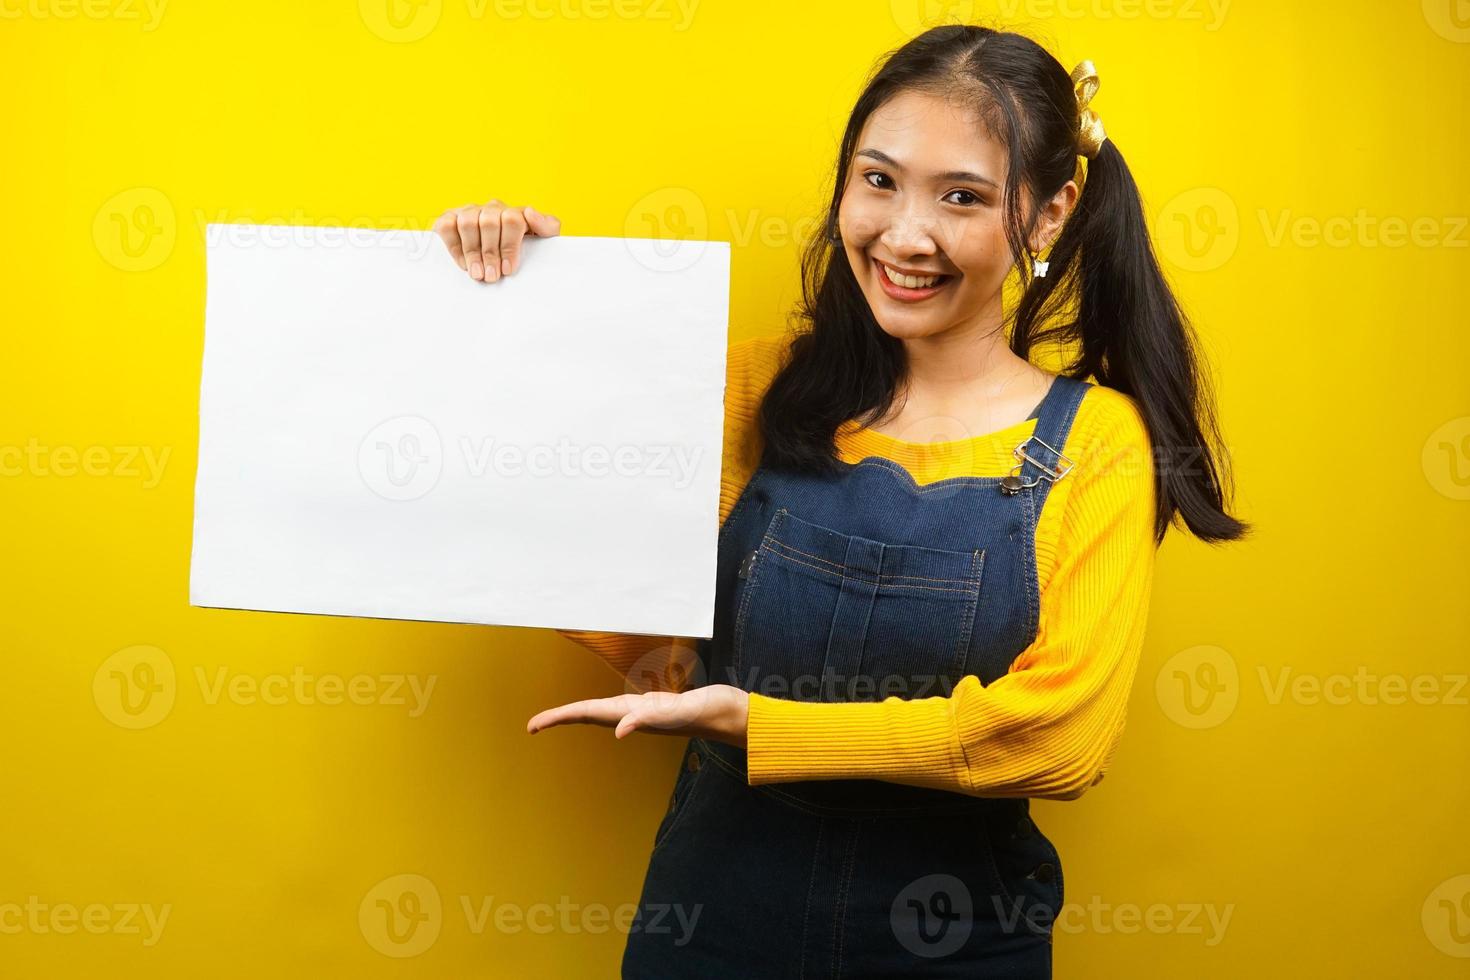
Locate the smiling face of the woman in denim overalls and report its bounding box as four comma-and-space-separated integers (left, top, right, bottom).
838, 93, 1050, 339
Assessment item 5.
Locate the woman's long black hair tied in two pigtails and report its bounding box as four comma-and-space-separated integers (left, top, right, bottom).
759, 25, 1250, 542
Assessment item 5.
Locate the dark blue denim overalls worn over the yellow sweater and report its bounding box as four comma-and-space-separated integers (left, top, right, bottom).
622, 376, 1091, 980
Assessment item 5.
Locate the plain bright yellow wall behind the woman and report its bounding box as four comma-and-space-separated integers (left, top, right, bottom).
0, 0, 1470, 977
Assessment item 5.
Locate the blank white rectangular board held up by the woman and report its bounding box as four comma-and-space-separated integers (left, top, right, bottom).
190, 225, 729, 636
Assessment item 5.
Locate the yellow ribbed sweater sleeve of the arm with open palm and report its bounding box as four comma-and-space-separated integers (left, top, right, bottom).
747, 388, 1155, 799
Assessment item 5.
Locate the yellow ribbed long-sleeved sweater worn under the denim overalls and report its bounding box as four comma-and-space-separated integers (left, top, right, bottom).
557, 336, 1155, 799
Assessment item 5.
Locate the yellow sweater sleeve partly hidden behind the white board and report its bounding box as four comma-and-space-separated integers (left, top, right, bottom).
556, 336, 786, 692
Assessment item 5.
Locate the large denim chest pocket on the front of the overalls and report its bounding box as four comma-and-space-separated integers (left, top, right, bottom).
731, 507, 985, 701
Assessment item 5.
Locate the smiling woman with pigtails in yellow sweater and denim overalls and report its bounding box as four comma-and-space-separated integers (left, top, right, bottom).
437, 26, 1247, 979
